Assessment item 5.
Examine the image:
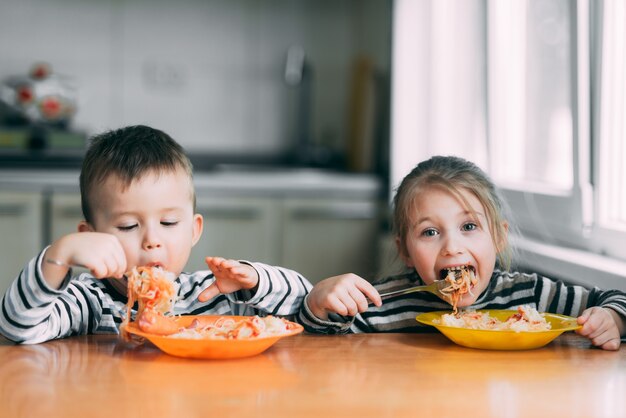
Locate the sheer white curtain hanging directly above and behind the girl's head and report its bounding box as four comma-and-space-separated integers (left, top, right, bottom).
391, 0, 488, 189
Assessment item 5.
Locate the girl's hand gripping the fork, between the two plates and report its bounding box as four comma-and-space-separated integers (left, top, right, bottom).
307, 273, 382, 320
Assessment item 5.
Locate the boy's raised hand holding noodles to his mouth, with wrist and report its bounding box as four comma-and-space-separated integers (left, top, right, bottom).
42, 232, 127, 289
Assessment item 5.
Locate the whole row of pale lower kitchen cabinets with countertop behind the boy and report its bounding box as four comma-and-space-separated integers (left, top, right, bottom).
0, 170, 384, 285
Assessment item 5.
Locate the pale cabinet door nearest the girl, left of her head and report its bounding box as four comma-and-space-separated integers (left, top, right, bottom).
281, 198, 378, 283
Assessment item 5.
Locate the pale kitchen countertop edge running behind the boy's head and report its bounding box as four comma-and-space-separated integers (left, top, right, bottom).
0, 167, 384, 199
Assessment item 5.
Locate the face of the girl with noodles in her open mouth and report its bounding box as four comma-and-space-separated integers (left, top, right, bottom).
403, 187, 496, 307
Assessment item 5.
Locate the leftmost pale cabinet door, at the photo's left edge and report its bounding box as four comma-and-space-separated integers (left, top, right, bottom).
0, 192, 43, 294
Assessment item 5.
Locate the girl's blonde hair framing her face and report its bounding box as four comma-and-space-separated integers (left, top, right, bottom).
393, 156, 512, 270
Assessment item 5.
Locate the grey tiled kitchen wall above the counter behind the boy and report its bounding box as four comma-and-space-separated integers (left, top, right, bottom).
0, 0, 391, 162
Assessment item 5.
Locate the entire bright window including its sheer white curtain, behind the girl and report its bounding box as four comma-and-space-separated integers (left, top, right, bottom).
391, 0, 626, 268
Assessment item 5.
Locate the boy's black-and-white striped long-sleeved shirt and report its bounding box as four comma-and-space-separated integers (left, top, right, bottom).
0, 252, 311, 344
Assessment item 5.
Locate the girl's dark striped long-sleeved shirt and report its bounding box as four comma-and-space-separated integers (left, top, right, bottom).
297, 270, 626, 334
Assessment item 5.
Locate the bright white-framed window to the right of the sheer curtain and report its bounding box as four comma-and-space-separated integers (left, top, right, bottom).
487, 0, 626, 259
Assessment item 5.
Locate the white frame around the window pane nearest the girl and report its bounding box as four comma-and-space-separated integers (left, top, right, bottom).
487, 0, 593, 248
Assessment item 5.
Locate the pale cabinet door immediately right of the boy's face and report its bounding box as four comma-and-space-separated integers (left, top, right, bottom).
186, 196, 280, 271
